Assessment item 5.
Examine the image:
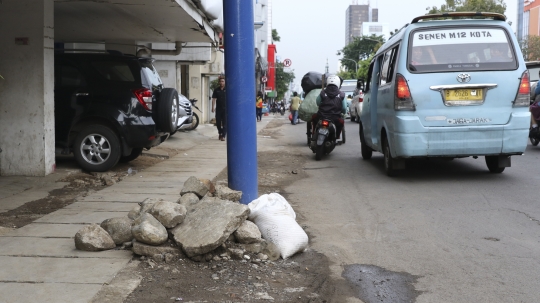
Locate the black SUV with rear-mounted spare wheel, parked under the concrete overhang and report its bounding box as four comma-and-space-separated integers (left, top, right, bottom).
54, 50, 178, 171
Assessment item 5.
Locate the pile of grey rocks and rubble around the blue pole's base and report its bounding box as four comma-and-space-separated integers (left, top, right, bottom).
75, 177, 280, 262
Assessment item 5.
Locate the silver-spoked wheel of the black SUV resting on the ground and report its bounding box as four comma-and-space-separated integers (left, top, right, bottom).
73, 125, 121, 172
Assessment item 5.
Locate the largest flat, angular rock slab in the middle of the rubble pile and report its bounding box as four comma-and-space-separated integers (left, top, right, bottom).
170, 199, 249, 257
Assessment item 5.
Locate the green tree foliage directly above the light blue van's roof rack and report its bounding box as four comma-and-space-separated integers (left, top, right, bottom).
426, 0, 506, 14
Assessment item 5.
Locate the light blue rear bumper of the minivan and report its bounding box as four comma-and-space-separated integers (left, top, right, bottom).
387, 112, 530, 158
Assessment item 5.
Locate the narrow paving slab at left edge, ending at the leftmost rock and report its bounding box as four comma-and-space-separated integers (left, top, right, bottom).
0, 223, 87, 238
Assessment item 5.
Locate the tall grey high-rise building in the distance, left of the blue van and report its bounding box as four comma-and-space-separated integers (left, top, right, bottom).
345, 4, 379, 45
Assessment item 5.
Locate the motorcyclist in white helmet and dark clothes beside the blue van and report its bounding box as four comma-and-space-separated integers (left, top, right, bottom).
313, 75, 347, 139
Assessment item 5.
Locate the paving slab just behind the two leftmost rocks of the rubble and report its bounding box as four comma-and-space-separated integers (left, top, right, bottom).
34, 208, 127, 224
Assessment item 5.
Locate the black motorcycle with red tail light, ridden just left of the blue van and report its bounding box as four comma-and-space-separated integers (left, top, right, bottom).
307, 114, 345, 161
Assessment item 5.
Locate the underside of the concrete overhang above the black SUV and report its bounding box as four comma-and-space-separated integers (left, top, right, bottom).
54, 0, 217, 42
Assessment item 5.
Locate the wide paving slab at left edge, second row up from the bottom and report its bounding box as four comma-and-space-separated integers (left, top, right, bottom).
0, 256, 129, 284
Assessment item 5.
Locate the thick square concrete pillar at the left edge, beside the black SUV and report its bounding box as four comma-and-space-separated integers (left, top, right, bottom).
0, 0, 55, 176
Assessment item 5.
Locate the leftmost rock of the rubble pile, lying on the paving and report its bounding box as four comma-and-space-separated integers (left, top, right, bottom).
75, 224, 116, 251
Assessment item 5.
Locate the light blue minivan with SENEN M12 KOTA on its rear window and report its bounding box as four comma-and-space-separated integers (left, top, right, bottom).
359, 12, 530, 176
